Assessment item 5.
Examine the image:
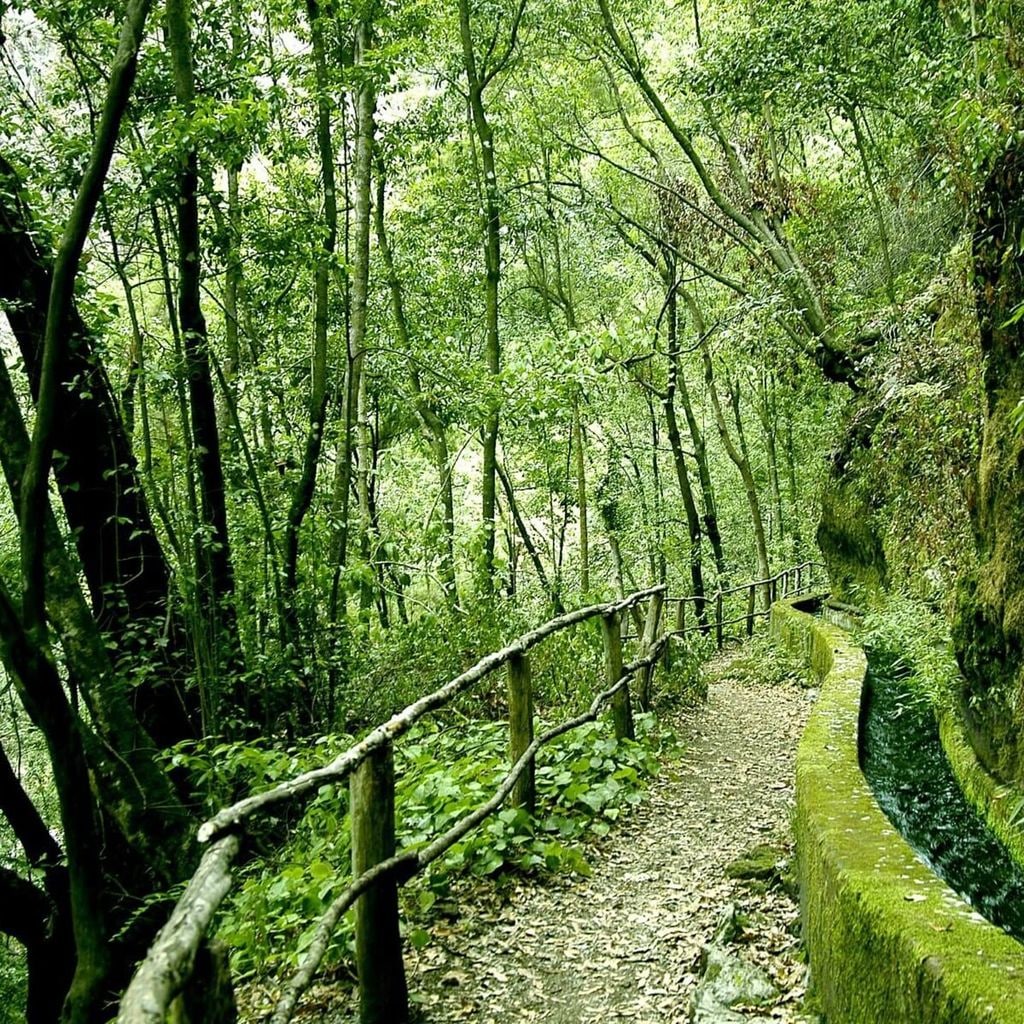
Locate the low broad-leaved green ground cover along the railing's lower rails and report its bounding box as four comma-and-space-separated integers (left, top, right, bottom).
174, 715, 675, 980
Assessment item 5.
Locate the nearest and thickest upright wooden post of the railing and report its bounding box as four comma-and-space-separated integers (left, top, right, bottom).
349, 743, 409, 1024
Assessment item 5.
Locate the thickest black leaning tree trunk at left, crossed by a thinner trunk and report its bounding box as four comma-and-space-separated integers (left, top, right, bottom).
0, 158, 196, 745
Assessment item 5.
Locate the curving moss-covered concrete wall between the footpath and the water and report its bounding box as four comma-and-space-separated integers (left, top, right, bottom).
771, 601, 1024, 1024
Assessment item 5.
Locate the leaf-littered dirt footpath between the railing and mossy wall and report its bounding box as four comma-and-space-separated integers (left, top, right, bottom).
408, 650, 811, 1024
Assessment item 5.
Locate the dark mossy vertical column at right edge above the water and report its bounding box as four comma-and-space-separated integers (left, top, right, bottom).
953, 134, 1024, 781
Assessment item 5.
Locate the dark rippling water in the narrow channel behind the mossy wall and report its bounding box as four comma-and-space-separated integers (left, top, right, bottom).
860, 651, 1024, 942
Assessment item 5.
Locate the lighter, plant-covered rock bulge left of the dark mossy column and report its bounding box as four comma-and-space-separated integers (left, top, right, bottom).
817, 245, 982, 608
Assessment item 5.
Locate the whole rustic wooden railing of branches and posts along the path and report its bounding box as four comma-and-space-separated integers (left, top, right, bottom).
118, 562, 816, 1024
